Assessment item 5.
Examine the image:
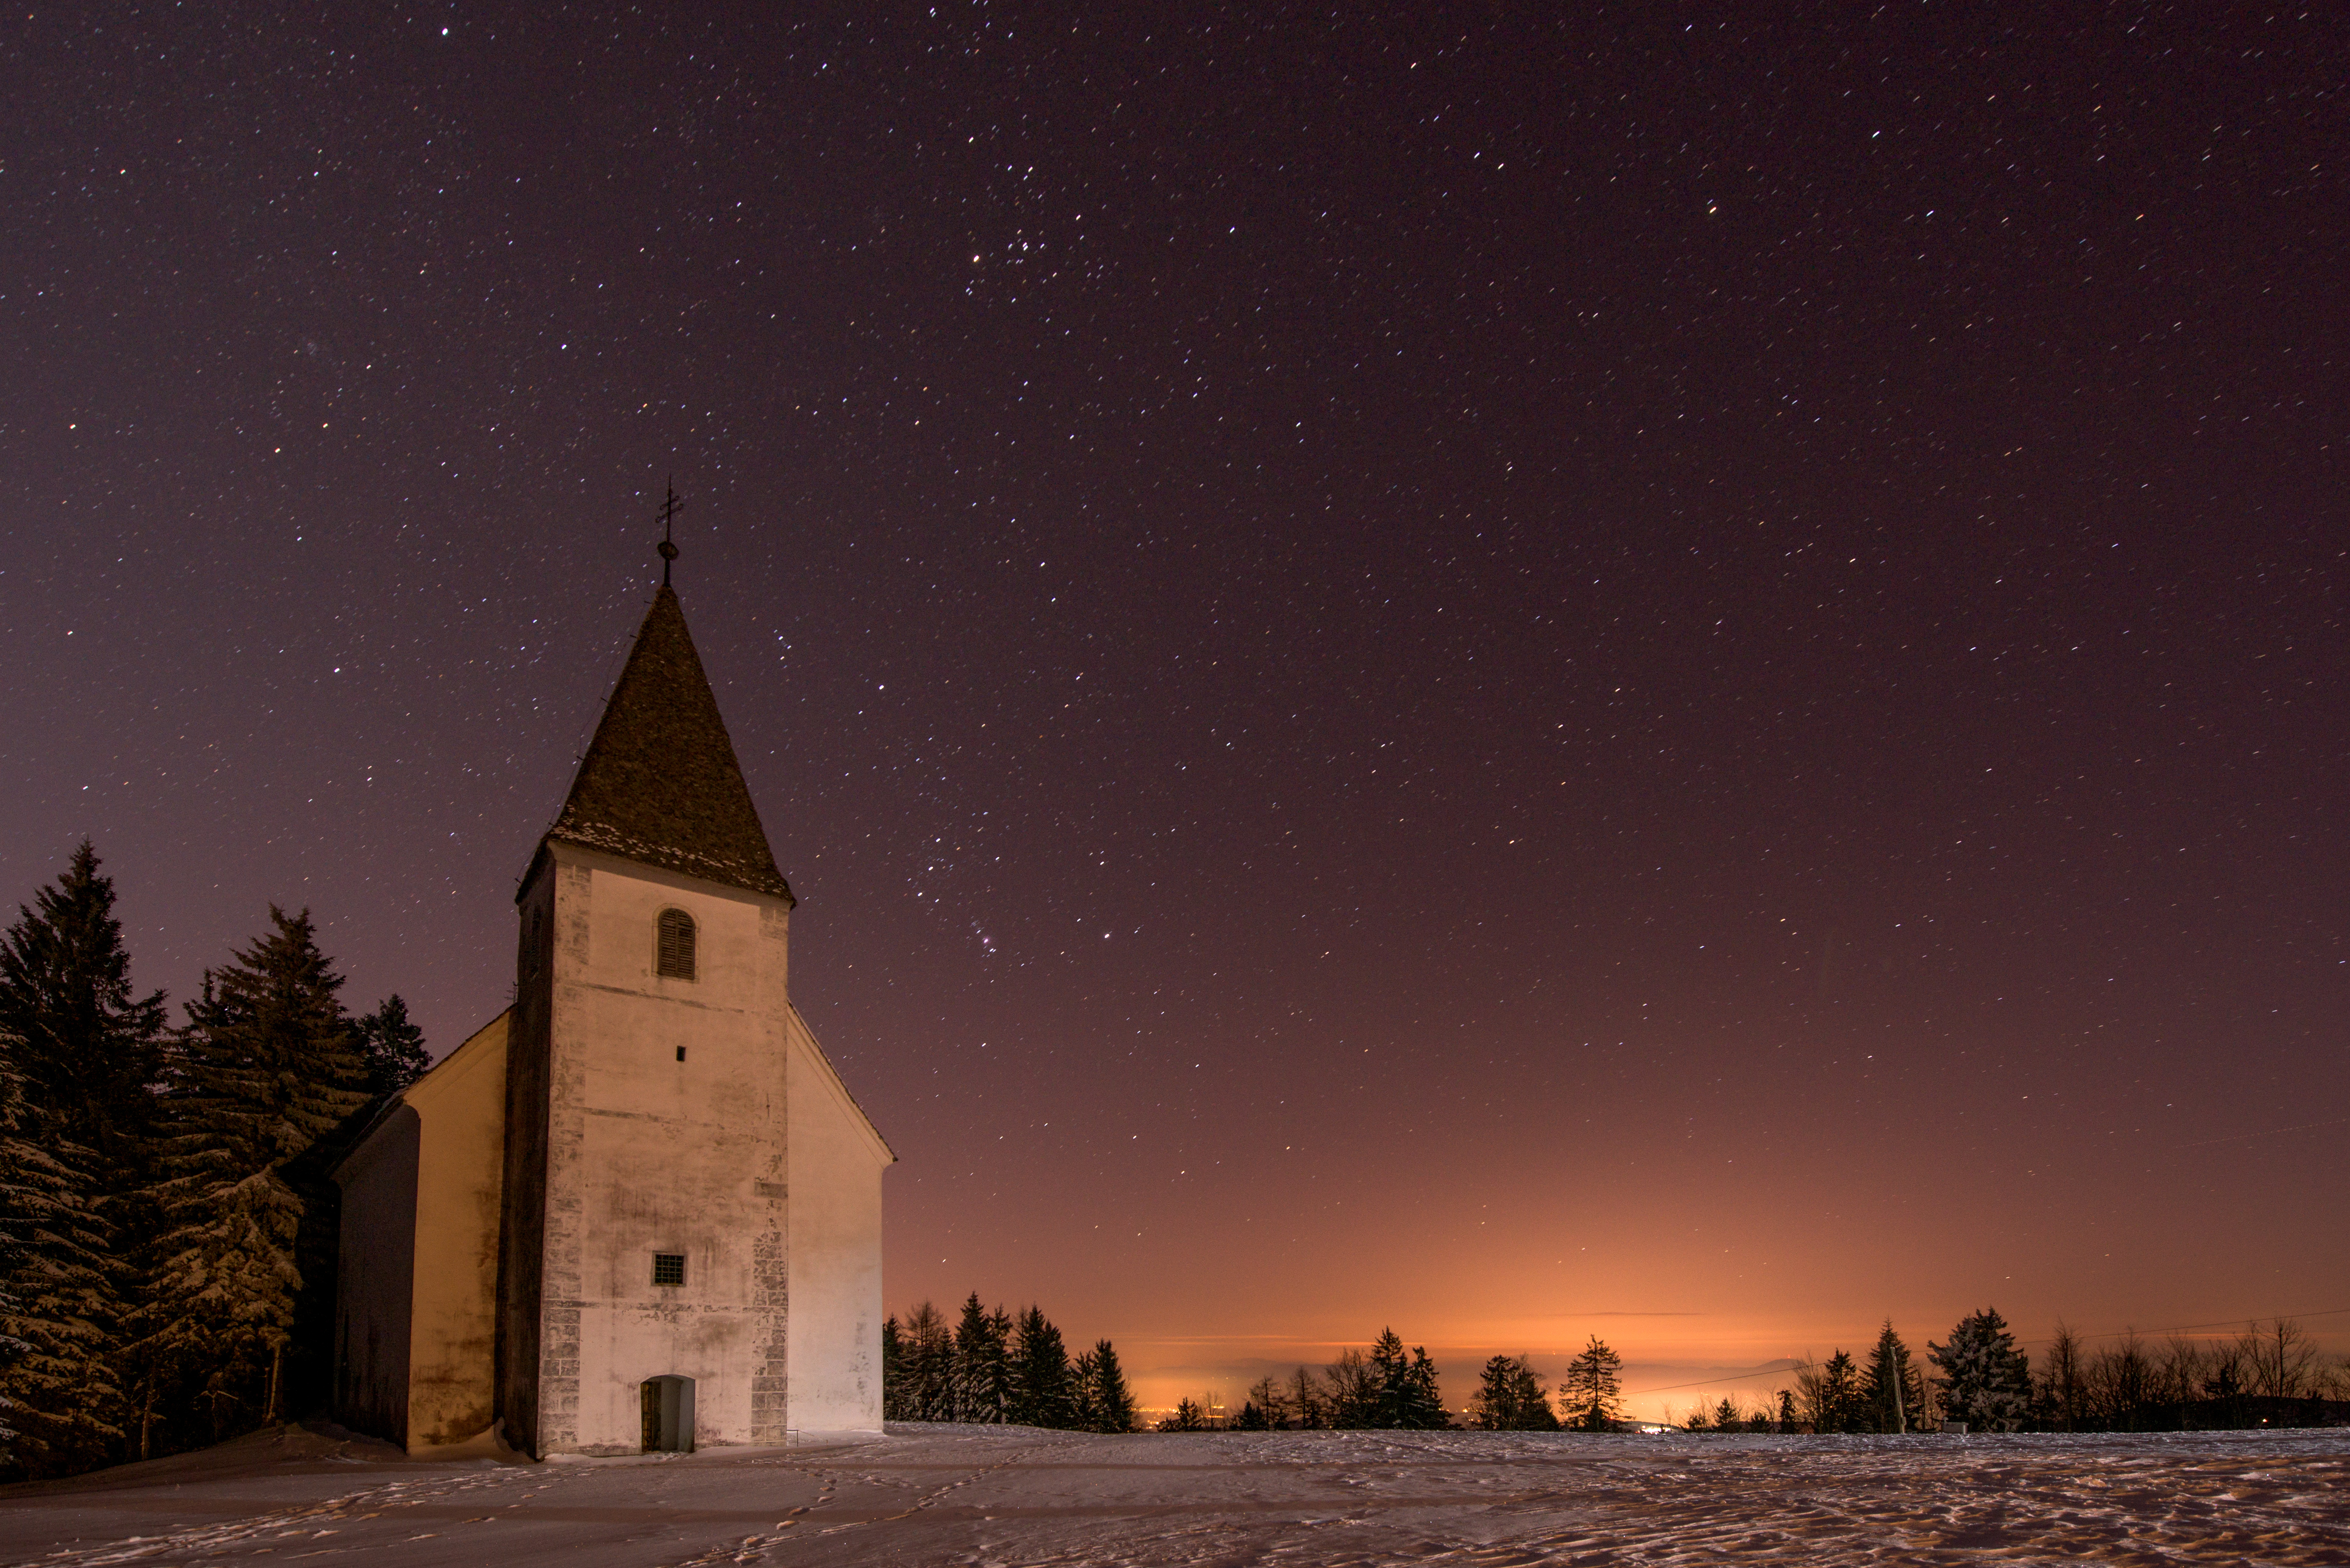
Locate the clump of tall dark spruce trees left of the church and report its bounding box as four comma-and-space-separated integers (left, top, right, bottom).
0, 839, 428, 1479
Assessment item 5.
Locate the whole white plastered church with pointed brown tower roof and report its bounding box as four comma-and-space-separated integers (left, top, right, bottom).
334, 566, 895, 1457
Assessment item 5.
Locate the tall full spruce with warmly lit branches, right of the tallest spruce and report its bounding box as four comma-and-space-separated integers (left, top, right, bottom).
134, 905, 369, 1441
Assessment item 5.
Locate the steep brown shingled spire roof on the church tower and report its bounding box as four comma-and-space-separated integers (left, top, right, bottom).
547, 585, 792, 903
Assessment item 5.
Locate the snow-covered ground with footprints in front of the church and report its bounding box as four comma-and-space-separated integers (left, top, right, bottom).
0, 1427, 2350, 1568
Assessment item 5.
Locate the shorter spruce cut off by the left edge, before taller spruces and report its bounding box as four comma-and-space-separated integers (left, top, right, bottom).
0, 1034, 122, 1476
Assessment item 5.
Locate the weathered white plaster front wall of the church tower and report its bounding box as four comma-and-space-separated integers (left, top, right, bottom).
538, 844, 790, 1453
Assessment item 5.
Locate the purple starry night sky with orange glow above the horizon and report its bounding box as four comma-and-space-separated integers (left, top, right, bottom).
0, 0, 2350, 1404
